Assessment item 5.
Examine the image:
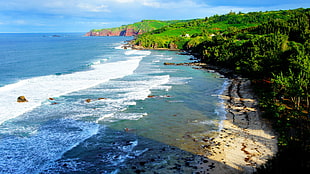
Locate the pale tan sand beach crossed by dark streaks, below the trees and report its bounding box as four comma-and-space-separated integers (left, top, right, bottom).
203, 78, 277, 174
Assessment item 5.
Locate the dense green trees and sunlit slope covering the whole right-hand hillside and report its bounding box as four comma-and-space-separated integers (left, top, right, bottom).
134, 8, 310, 173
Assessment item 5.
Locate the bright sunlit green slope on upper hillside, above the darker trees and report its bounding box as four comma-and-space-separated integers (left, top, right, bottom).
136, 11, 298, 49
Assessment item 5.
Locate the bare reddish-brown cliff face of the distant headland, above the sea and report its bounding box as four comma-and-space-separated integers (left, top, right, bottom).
85, 28, 144, 36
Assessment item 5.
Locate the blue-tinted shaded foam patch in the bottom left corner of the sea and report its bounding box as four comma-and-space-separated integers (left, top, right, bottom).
0, 119, 99, 174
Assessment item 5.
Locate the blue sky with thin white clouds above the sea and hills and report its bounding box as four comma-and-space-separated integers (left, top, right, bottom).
0, 0, 310, 33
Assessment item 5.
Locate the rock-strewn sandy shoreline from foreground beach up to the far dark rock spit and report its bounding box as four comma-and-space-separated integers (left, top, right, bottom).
118, 47, 277, 174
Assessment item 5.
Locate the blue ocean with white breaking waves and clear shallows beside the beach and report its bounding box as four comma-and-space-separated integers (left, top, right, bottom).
0, 33, 227, 174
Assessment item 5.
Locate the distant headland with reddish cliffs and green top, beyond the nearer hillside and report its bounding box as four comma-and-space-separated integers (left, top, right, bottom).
85, 20, 185, 36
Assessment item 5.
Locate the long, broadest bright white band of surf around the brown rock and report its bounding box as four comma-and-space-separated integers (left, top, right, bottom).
0, 50, 150, 124
